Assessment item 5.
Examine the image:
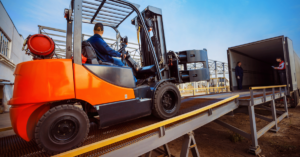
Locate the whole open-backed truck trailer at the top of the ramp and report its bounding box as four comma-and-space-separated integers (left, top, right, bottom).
227, 36, 300, 107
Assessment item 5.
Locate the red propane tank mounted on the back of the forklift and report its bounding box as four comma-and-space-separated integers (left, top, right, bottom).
22, 34, 55, 60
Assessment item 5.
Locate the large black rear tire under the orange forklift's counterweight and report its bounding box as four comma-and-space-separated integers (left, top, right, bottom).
35, 105, 90, 154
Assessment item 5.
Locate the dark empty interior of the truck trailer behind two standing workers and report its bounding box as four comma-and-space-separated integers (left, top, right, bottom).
227, 36, 285, 91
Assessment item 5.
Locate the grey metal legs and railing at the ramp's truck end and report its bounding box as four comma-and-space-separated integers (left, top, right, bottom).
215, 85, 288, 155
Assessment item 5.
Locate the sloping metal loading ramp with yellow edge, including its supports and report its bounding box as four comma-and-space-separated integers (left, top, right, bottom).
0, 86, 288, 157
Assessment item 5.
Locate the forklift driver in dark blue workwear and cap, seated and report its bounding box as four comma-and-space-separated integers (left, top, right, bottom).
87, 23, 126, 66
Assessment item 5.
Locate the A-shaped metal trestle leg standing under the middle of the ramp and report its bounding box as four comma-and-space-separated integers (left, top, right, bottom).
180, 132, 200, 157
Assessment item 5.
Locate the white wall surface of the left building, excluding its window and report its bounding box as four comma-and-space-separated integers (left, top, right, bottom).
0, 1, 31, 82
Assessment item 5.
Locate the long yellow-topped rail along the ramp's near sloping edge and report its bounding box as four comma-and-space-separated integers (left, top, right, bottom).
55, 95, 239, 157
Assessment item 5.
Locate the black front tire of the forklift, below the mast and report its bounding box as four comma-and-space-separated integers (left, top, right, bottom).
153, 82, 181, 119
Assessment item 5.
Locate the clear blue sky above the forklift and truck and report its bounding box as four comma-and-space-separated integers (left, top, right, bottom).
1, 0, 300, 61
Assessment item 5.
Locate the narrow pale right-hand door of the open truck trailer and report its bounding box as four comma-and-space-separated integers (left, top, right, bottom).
285, 37, 297, 91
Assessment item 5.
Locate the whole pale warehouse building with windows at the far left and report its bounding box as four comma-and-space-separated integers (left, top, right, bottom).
0, 1, 31, 113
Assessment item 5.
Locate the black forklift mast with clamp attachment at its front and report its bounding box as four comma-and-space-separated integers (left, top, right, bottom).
131, 6, 210, 83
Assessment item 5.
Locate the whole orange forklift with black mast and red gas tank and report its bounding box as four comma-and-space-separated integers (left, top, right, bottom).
9, 0, 209, 154
